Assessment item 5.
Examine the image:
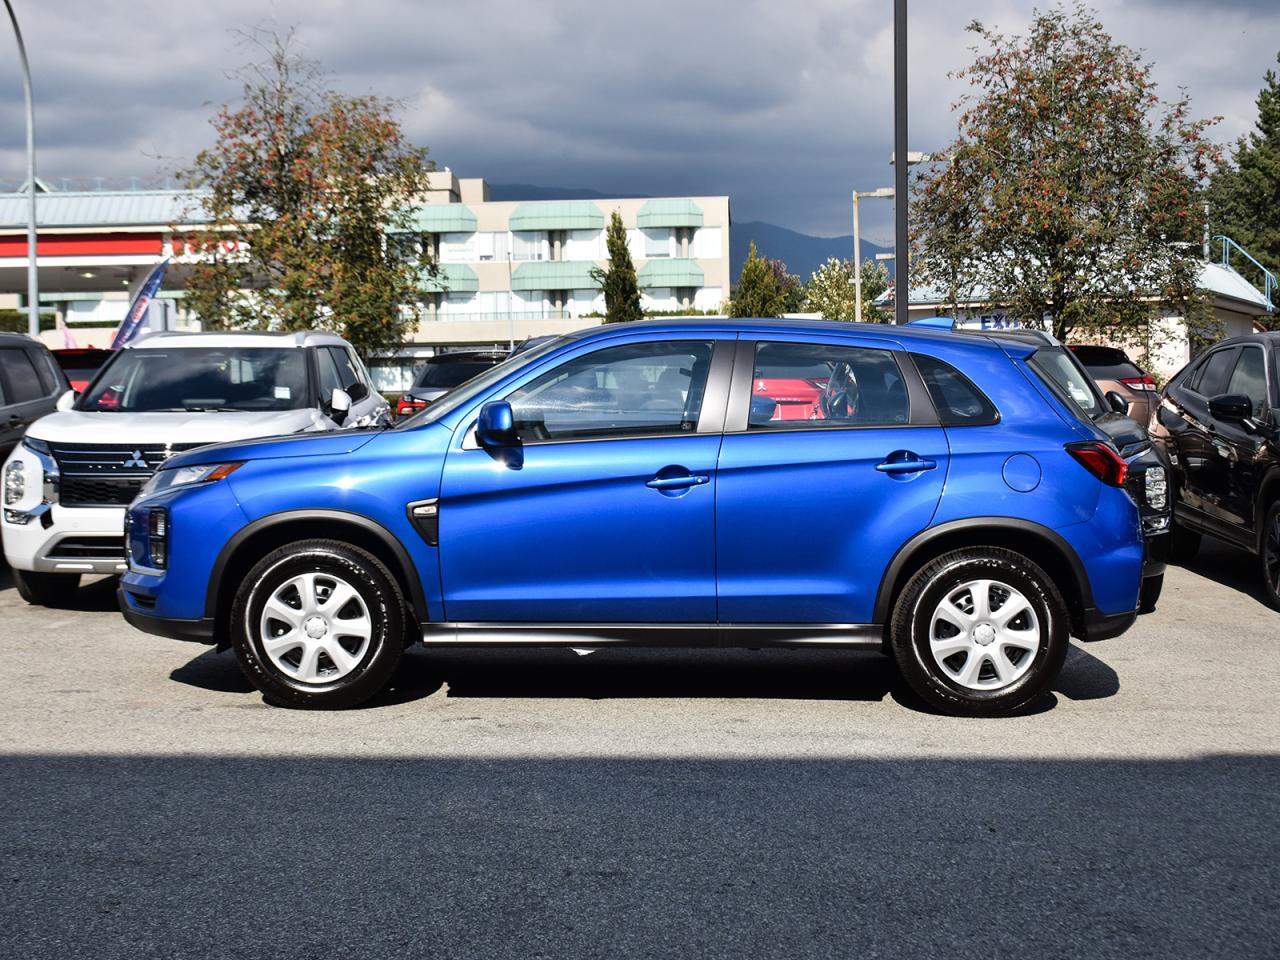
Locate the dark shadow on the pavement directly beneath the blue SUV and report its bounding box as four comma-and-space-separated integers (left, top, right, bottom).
169, 645, 1120, 714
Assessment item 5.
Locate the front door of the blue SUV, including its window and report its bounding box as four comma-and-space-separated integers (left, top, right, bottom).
439, 334, 732, 623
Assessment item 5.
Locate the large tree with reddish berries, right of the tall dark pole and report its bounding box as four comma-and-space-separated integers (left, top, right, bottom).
911, 5, 1217, 338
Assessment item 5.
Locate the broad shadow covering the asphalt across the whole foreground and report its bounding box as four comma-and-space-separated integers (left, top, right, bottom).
0, 757, 1280, 960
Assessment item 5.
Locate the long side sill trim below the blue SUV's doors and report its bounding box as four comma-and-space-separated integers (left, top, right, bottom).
422, 621, 884, 650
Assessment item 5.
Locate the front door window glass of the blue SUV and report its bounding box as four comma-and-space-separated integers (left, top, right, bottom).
507, 340, 712, 443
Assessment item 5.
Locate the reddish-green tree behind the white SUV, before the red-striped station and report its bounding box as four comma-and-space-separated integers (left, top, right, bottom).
184, 33, 434, 353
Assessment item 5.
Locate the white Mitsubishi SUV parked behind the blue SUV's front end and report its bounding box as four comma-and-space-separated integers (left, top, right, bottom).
3, 333, 389, 604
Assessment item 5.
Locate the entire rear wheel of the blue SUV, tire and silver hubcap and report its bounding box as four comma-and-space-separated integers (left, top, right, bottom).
890, 547, 1070, 717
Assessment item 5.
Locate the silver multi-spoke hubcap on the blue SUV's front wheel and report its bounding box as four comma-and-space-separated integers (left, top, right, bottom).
259, 573, 374, 684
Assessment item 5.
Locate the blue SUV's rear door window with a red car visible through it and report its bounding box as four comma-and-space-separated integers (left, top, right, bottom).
748, 343, 911, 430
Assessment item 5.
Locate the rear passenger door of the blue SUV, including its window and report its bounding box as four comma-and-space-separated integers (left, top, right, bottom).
716, 335, 948, 623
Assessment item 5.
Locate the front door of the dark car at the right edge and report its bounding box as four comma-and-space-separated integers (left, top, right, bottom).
1212, 343, 1271, 543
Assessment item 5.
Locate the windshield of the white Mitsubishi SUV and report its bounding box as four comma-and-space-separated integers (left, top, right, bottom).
77, 347, 310, 413
